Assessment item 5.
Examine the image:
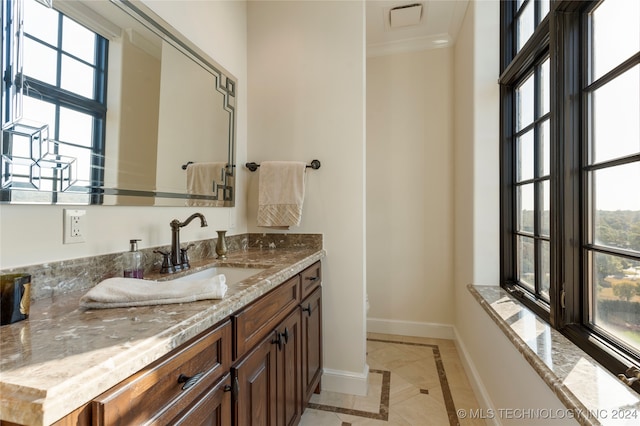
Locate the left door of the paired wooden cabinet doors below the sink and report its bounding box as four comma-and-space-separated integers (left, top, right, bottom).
231, 333, 279, 426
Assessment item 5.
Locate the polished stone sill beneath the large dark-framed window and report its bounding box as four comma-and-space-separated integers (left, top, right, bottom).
467, 284, 640, 425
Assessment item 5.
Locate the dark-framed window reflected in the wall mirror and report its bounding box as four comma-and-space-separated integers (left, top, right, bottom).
2, 0, 107, 203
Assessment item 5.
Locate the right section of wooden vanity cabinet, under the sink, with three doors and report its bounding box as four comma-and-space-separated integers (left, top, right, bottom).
232, 262, 322, 426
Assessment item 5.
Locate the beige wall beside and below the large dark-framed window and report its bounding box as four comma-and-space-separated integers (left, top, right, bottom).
454, 1, 576, 425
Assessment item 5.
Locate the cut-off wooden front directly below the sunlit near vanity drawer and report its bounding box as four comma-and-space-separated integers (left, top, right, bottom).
170, 373, 231, 426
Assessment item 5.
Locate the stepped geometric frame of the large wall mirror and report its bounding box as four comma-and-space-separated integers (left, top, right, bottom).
0, 0, 237, 207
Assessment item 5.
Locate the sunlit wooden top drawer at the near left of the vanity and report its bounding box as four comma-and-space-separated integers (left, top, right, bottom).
92, 321, 232, 426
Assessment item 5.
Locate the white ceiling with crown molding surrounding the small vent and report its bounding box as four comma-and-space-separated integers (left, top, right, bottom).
366, 0, 469, 56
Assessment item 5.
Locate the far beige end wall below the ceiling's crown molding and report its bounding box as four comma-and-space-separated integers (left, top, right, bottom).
367, 48, 454, 337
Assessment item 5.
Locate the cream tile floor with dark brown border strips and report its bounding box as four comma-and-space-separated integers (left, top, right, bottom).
300, 333, 485, 426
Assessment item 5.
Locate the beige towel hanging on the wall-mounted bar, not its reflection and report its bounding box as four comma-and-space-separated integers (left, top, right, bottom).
258, 161, 306, 229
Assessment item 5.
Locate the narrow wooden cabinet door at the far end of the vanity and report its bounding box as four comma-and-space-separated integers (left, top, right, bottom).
301, 287, 322, 407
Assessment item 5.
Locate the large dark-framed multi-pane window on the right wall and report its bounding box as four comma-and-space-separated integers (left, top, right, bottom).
500, 0, 640, 392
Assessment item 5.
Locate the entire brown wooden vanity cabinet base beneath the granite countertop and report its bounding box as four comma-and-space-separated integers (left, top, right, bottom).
31, 262, 322, 426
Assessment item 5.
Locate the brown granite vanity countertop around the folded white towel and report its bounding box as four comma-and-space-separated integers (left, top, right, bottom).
0, 248, 325, 425
